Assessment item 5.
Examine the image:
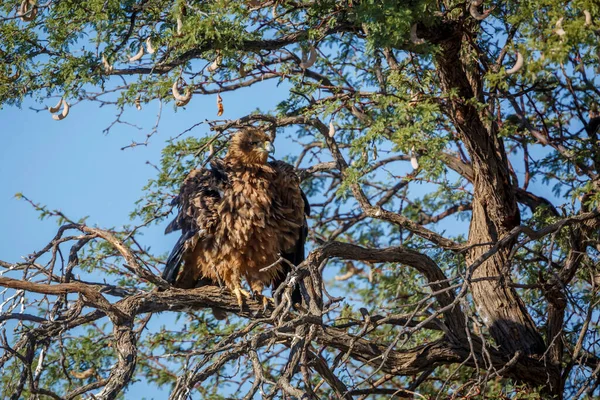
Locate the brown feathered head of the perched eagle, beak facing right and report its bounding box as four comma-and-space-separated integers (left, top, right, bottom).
227, 128, 275, 166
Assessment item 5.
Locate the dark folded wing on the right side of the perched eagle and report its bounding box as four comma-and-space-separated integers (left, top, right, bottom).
269, 161, 310, 303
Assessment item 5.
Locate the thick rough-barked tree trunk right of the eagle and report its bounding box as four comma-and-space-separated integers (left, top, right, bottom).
436, 26, 545, 354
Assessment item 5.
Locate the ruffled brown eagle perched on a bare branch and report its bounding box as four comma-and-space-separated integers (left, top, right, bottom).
162, 128, 310, 319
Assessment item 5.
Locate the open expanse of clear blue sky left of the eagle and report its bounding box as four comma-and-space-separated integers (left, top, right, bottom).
0, 77, 289, 399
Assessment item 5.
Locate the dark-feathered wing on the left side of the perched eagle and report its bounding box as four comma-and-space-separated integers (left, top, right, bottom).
162, 160, 228, 287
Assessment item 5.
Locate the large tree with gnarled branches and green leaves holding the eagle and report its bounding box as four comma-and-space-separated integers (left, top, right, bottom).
0, 0, 600, 399
